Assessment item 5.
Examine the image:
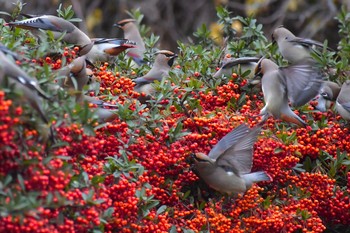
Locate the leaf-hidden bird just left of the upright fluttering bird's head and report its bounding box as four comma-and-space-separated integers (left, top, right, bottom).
213, 57, 260, 79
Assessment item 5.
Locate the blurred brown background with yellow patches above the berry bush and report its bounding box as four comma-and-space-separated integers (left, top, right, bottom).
0, 0, 350, 51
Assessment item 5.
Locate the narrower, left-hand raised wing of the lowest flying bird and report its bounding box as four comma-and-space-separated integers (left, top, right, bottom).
208, 124, 249, 160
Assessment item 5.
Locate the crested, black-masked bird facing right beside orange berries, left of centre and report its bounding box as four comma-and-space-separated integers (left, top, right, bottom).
133, 50, 177, 101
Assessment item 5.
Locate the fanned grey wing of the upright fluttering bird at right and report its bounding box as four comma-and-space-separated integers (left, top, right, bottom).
279, 63, 323, 106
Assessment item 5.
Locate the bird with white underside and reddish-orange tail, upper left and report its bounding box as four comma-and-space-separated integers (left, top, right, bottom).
86, 38, 136, 62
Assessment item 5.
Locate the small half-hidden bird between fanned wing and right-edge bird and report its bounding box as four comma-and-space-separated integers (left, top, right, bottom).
315, 81, 341, 112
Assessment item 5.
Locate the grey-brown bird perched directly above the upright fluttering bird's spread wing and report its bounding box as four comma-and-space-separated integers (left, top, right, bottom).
271, 26, 323, 64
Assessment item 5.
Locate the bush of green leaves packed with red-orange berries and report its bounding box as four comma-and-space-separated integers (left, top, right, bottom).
0, 3, 350, 233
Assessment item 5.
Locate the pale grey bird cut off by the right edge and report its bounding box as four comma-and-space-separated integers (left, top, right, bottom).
335, 80, 350, 121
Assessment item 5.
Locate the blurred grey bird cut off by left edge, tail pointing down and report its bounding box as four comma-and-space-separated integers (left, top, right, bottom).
0, 46, 54, 139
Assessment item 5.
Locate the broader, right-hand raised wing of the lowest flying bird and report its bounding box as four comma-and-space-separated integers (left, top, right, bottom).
216, 127, 261, 175
